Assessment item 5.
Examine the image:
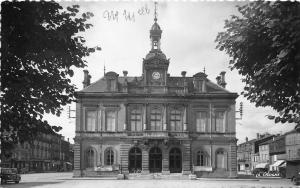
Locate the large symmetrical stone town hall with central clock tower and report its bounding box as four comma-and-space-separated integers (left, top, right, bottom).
74, 7, 238, 177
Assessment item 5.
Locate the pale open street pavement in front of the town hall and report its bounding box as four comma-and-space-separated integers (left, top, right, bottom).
2, 172, 300, 188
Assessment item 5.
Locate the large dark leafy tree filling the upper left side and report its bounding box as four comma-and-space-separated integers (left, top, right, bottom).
0, 1, 100, 155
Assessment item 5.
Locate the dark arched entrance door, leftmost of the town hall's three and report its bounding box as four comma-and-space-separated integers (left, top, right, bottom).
128, 147, 142, 173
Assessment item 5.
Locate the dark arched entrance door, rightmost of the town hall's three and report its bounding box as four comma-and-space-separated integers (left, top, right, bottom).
169, 148, 182, 173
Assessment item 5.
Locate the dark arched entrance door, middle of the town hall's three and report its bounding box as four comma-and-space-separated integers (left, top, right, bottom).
149, 147, 162, 173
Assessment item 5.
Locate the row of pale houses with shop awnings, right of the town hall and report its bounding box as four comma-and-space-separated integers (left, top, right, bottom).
237, 130, 300, 178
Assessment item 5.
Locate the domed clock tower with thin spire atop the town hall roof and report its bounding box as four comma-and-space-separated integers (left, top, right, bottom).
143, 2, 169, 93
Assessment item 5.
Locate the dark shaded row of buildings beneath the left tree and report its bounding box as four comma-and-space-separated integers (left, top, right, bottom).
1, 133, 73, 173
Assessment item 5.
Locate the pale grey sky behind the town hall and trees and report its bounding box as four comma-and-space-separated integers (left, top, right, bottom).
45, 1, 294, 143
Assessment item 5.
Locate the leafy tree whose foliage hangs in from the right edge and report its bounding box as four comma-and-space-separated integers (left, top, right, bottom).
216, 1, 300, 127
